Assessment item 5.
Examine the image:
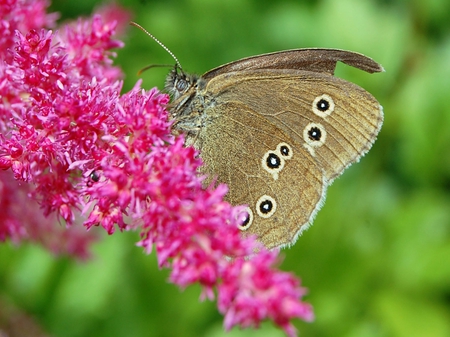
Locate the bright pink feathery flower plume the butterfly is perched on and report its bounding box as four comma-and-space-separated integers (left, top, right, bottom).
0, 0, 312, 336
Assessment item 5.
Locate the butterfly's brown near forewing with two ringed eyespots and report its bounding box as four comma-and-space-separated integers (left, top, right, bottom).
208, 70, 383, 182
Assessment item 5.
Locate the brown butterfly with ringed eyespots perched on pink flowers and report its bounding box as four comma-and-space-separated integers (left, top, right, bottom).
130, 22, 383, 248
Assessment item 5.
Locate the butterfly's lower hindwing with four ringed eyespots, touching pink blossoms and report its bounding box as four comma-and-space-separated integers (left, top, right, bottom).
195, 100, 326, 248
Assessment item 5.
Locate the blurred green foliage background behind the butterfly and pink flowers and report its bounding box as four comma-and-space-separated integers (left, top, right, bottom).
0, 0, 450, 337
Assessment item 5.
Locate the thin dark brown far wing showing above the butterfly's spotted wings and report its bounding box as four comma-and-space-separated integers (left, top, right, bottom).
202, 48, 384, 80
